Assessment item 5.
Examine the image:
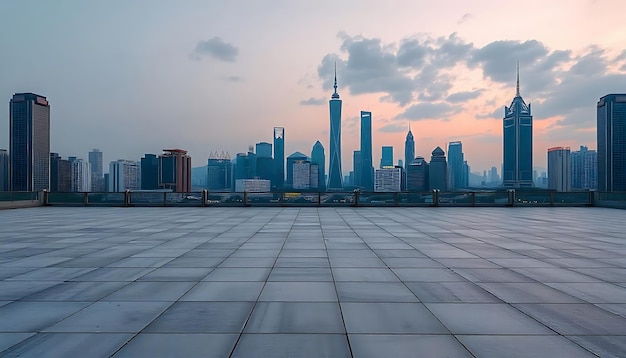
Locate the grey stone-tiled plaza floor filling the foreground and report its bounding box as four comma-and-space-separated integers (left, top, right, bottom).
0, 207, 626, 358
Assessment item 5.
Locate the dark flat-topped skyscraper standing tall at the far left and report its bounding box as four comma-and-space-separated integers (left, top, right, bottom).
9, 93, 50, 191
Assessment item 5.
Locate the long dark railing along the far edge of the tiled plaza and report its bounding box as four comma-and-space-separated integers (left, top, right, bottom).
0, 190, 626, 208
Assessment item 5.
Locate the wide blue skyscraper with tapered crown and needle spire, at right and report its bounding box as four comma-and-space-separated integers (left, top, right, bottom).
502, 65, 534, 188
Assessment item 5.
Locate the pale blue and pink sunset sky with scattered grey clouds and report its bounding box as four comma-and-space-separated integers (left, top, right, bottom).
0, 0, 626, 173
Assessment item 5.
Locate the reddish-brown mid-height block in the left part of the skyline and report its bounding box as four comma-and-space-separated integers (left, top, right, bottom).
158, 149, 191, 193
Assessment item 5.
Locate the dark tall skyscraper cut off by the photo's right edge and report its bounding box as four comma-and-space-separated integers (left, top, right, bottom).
597, 93, 626, 192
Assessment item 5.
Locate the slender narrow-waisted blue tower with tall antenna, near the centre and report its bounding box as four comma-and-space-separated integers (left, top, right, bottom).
327, 66, 343, 190
